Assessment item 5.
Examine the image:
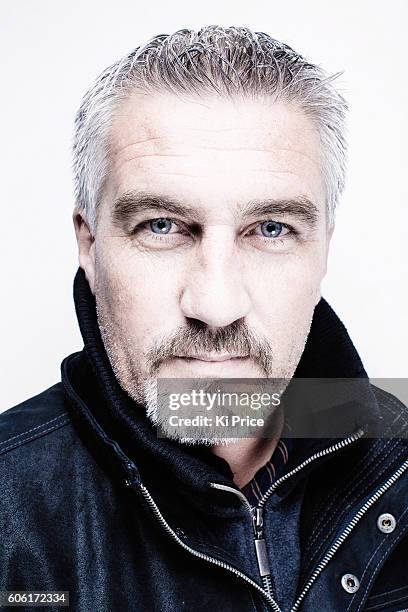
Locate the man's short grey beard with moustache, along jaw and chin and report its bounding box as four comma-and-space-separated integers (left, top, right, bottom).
95, 292, 312, 446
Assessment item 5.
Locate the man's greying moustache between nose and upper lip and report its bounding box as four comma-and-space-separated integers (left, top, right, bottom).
147, 319, 272, 377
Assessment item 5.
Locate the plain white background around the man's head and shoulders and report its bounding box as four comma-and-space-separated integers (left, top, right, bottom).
0, 0, 408, 411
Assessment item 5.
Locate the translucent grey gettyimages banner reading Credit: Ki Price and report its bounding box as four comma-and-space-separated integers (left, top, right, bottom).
152, 378, 408, 443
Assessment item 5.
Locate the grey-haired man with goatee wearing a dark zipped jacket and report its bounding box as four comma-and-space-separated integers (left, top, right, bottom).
0, 26, 408, 612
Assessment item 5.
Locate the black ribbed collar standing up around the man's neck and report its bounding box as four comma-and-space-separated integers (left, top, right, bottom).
61, 268, 379, 514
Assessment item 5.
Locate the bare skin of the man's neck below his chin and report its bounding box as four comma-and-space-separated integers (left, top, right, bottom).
211, 410, 283, 489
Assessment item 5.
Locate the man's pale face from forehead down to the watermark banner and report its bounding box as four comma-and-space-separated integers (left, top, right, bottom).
76, 93, 330, 420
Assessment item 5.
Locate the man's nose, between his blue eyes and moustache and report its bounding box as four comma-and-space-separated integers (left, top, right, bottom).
180, 228, 251, 328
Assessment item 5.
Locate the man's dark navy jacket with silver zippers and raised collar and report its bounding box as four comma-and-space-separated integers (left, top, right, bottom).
0, 271, 408, 612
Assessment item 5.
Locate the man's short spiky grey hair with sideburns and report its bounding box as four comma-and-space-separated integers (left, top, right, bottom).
73, 26, 347, 231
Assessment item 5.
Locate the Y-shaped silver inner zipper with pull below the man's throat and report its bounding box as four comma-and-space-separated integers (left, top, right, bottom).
210, 429, 364, 610
